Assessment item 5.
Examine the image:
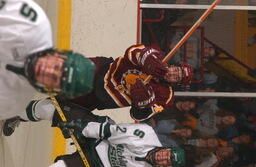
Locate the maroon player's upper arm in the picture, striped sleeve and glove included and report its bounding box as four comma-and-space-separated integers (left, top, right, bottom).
124, 45, 167, 78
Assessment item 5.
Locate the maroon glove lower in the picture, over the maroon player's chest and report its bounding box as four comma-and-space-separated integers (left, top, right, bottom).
130, 79, 155, 109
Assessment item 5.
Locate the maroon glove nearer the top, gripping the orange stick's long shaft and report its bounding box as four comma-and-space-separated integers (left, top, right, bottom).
141, 49, 167, 78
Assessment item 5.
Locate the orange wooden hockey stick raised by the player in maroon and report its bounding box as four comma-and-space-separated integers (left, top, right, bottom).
144, 0, 221, 83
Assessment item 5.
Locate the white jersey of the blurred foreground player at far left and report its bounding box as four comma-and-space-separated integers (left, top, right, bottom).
0, 0, 53, 120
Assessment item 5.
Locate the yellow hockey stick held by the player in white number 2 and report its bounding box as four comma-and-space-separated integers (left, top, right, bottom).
50, 96, 90, 167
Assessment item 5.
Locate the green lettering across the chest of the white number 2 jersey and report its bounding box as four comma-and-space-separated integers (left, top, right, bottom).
108, 144, 127, 167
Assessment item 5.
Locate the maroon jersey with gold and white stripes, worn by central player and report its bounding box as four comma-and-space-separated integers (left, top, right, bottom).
104, 45, 173, 116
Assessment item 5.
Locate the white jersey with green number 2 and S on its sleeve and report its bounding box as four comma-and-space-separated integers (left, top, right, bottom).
82, 122, 162, 167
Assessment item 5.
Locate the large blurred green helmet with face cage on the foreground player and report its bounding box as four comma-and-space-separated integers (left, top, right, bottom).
6, 48, 95, 98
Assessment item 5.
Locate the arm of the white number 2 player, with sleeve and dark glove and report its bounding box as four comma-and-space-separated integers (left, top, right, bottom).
59, 119, 154, 145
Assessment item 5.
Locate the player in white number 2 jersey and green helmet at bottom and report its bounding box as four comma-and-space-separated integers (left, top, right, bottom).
50, 119, 185, 167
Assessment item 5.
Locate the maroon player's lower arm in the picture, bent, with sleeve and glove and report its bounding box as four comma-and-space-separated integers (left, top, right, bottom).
130, 80, 173, 121
